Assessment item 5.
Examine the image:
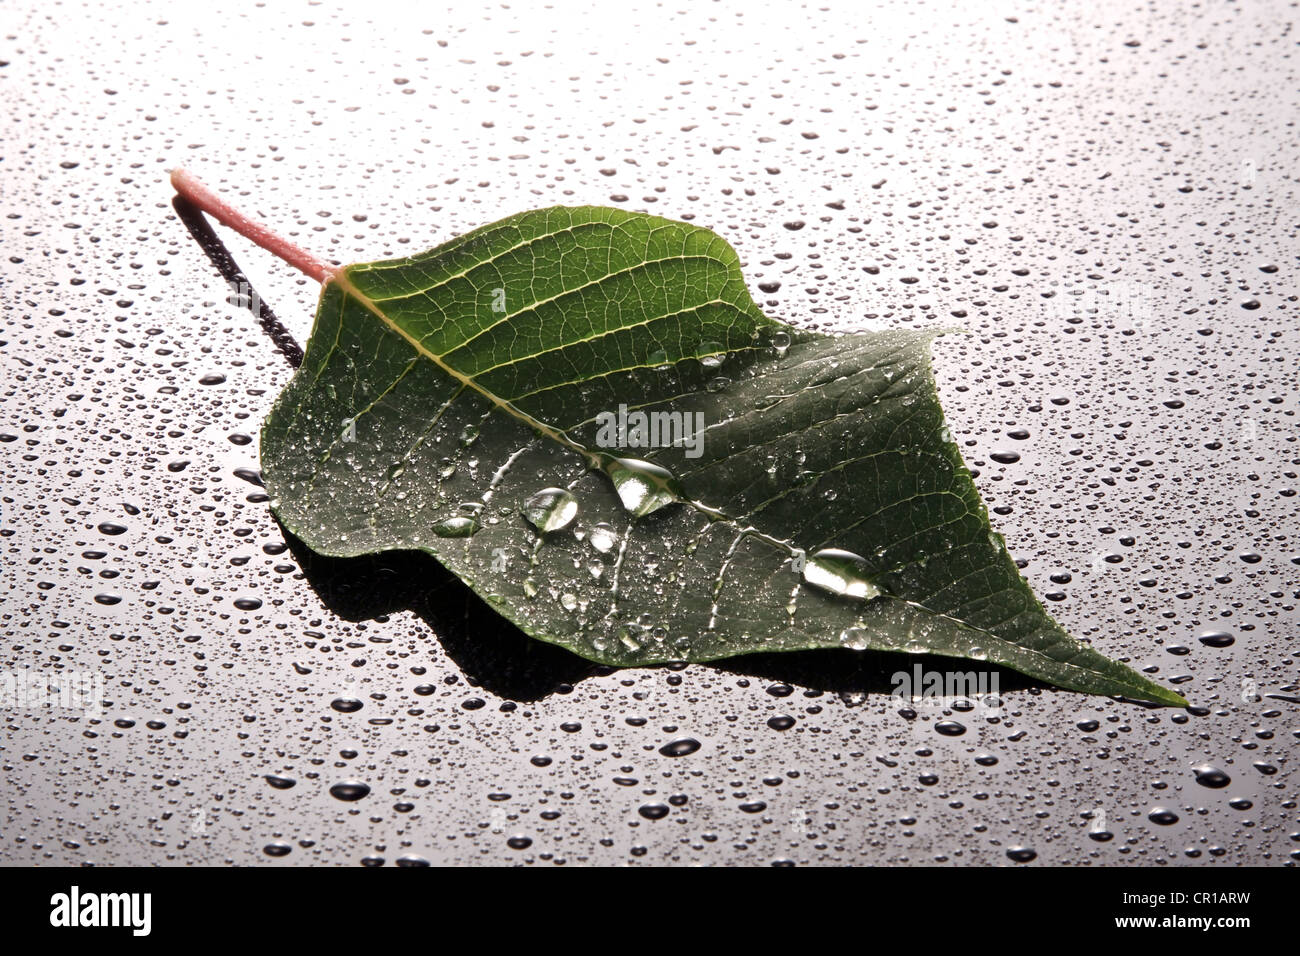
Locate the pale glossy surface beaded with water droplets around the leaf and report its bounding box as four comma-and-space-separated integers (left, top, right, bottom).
0, 3, 1300, 866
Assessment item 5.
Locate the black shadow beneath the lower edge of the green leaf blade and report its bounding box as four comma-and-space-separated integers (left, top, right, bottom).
281, 527, 1043, 702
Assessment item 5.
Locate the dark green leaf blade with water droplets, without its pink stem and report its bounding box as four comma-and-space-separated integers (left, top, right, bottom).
261, 207, 1186, 705
